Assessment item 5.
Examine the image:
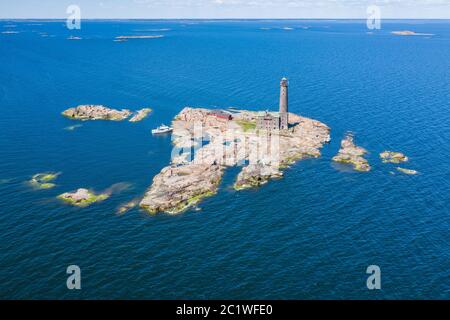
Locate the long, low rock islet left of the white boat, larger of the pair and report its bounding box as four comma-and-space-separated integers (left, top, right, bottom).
62, 105, 132, 121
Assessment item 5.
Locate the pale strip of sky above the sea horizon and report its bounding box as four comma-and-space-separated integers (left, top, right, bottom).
0, 0, 450, 19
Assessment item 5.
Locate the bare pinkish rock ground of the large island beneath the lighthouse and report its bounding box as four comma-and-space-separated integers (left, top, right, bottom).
140, 107, 330, 214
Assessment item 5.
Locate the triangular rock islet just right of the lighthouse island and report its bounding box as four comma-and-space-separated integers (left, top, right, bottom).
332, 134, 370, 172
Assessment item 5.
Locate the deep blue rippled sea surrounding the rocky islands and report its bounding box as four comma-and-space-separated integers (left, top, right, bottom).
0, 20, 450, 299
